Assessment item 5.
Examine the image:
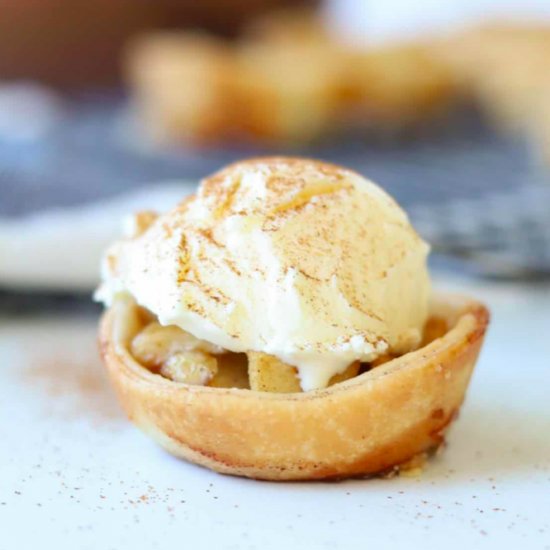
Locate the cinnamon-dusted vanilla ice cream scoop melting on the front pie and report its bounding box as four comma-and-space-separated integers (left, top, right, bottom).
96, 158, 430, 391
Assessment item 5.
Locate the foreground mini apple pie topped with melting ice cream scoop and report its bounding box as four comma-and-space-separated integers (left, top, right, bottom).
96, 158, 488, 480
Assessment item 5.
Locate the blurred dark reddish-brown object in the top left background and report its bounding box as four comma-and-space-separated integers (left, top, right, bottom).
0, 0, 318, 87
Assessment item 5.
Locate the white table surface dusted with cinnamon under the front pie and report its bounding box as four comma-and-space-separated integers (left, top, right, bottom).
0, 284, 550, 550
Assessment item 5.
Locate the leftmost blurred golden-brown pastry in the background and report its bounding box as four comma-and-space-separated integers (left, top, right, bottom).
125, 31, 246, 144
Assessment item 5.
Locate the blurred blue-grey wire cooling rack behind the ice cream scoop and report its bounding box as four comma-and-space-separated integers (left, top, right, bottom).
0, 96, 550, 278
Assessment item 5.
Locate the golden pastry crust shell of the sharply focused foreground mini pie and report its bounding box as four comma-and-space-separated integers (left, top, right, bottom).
100, 296, 489, 480
